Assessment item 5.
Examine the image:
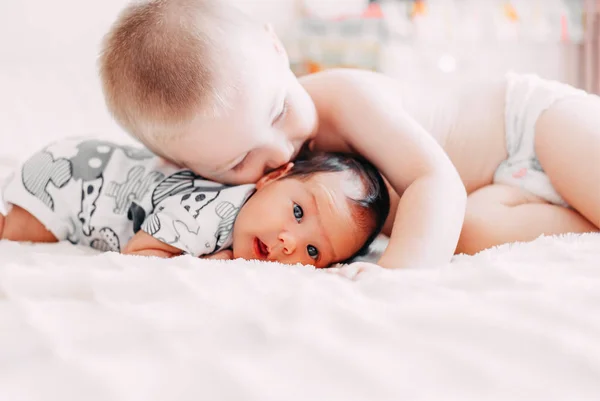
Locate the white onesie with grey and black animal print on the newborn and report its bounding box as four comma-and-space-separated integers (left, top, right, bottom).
3, 138, 254, 256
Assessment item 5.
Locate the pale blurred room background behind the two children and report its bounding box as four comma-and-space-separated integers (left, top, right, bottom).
0, 0, 600, 161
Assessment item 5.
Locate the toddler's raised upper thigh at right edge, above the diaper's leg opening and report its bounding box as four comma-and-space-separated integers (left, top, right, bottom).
535, 95, 600, 227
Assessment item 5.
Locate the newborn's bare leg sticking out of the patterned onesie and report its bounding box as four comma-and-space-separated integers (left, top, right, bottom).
0, 205, 58, 242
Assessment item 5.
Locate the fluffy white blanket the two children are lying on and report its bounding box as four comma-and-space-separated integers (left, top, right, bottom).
0, 234, 600, 401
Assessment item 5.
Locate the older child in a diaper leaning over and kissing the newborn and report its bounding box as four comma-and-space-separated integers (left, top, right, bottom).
100, 0, 600, 267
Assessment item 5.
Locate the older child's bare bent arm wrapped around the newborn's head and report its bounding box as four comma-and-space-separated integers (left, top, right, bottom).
320, 71, 466, 268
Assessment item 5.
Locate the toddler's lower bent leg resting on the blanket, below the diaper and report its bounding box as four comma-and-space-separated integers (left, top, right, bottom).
456, 184, 599, 255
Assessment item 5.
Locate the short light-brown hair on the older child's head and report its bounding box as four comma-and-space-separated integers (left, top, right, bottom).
99, 0, 254, 154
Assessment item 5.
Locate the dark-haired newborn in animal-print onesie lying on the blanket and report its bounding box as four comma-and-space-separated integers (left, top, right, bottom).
0, 139, 389, 267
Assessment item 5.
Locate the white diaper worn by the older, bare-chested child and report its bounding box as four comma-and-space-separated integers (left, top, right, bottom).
494, 72, 593, 206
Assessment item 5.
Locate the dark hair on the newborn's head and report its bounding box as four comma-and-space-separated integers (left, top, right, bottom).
284, 152, 390, 260
